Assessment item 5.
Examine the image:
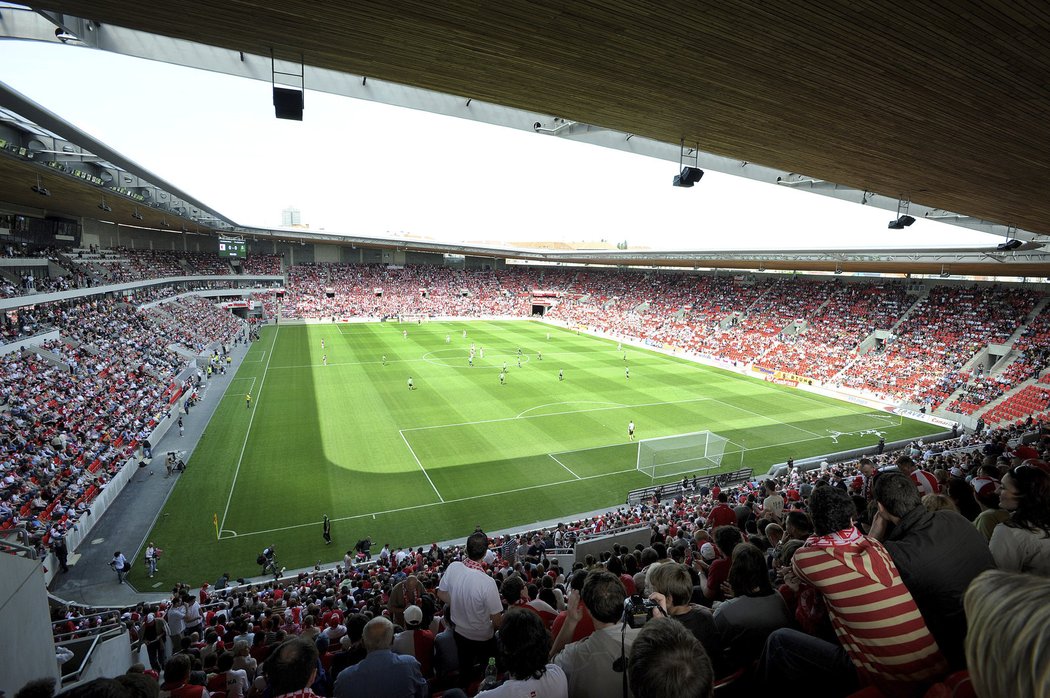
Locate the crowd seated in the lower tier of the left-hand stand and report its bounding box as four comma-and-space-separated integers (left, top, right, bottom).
0, 298, 240, 558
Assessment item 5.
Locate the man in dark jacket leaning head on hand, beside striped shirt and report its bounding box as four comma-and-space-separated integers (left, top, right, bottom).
870, 471, 995, 669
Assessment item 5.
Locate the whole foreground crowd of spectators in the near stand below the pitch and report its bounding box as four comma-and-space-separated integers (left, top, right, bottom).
26, 421, 1050, 698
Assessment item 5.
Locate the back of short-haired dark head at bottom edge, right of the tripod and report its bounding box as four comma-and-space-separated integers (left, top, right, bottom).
625, 618, 714, 698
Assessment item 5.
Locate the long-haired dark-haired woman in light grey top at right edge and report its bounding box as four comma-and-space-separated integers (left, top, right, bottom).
988, 463, 1050, 576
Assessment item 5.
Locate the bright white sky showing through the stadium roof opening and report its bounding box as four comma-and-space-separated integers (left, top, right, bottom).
0, 40, 1002, 250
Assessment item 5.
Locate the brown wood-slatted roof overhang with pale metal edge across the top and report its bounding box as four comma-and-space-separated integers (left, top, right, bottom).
0, 0, 1050, 275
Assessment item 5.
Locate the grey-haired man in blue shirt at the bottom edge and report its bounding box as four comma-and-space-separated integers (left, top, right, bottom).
334, 616, 427, 698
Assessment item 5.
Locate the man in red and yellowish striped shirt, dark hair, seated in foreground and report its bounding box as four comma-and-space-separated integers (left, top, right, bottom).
759, 486, 947, 695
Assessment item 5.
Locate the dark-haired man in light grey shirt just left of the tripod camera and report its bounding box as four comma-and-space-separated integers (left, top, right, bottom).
551, 571, 639, 698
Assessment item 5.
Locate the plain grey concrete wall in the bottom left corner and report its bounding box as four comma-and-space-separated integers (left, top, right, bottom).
0, 553, 61, 696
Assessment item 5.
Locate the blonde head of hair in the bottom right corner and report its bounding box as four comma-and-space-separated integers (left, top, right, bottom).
963, 570, 1050, 698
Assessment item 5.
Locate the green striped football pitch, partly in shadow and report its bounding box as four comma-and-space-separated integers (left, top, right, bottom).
131, 321, 939, 590
